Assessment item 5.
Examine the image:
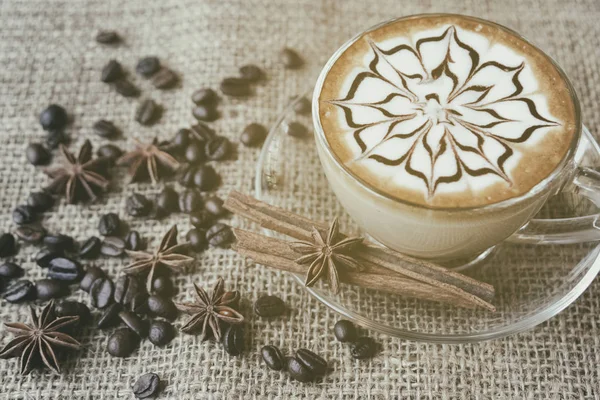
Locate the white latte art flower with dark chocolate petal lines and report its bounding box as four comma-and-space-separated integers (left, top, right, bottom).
330, 26, 560, 198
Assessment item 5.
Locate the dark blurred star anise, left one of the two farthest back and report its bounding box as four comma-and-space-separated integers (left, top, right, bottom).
44, 140, 109, 203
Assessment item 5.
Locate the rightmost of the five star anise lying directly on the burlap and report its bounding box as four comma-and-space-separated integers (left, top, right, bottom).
177, 277, 244, 341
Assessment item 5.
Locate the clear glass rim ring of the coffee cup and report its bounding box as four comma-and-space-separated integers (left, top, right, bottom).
312, 13, 582, 212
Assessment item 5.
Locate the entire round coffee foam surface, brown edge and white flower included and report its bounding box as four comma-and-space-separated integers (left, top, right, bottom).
319, 16, 576, 207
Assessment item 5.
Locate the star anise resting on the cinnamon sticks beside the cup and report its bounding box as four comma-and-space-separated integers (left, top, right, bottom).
290, 218, 363, 294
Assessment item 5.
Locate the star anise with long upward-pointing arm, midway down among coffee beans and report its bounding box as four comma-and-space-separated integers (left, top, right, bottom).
123, 225, 194, 292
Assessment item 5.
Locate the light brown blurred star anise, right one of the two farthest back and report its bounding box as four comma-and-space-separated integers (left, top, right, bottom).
117, 138, 179, 183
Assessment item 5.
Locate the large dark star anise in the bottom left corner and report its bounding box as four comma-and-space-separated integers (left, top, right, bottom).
0, 301, 81, 375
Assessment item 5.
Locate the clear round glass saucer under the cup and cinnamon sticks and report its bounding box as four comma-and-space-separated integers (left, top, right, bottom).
255, 96, 600, 343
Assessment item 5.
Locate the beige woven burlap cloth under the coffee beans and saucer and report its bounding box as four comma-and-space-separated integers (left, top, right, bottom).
0, 0, 600, 399
